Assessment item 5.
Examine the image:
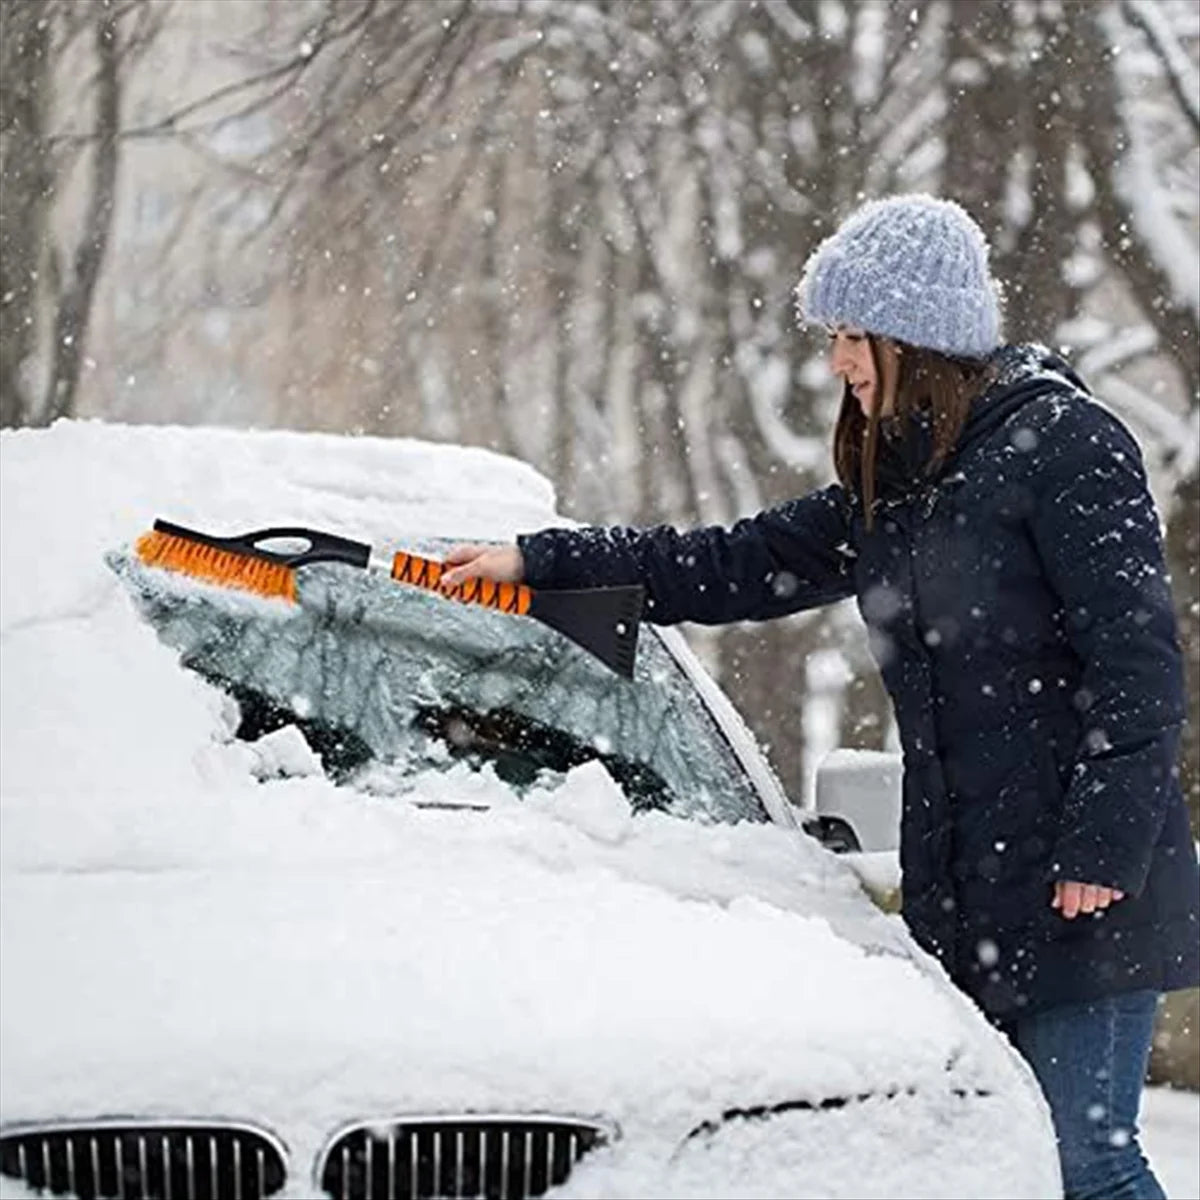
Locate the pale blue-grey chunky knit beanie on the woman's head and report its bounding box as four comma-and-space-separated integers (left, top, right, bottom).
797, 196, 1000, 358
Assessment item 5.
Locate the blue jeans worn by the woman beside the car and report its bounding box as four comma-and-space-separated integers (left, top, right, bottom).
1004, 991, 1166, 1200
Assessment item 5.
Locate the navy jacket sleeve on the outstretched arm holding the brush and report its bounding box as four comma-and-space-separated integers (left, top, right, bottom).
517, 484, 854, 625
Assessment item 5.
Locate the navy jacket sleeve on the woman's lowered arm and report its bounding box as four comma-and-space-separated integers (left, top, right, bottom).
1031, 397, 1186, 895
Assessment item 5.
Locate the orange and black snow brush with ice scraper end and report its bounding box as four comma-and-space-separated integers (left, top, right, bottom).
134, 521, 644, 679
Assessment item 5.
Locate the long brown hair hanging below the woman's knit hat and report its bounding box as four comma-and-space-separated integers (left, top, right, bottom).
833, 334, 989, 529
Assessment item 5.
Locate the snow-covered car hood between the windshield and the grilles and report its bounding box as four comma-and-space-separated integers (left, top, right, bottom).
0, 764, 1022, 1152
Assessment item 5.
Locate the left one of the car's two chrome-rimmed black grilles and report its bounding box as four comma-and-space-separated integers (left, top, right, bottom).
0, 1117, 287, 1200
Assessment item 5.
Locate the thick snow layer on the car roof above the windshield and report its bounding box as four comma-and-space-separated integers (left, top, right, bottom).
0, 421, 554, 628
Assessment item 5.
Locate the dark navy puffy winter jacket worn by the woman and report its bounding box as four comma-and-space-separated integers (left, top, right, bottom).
520, 347, 1200, 1016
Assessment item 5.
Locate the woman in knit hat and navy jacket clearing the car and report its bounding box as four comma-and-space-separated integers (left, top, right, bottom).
445, 196, 1200, 1198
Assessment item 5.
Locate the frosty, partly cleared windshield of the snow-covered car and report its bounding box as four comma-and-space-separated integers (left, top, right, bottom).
109, 541, 767, 822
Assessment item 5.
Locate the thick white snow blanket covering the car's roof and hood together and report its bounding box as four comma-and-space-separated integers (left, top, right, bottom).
0, 422, 1051, 1190
